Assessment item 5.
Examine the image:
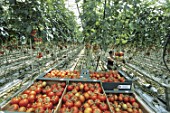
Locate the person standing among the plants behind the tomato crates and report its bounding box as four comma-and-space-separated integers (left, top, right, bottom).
107, 51, 116, 70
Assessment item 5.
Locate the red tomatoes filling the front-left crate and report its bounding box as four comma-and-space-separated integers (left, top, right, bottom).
7, 81, 66, 113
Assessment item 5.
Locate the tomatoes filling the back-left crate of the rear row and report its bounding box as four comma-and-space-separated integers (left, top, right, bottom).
45, 69, 80, 79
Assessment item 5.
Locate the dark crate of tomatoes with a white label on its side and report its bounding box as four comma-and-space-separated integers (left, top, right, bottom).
90, 70, 132, 90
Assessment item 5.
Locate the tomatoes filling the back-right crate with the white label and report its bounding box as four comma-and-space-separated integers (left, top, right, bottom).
90, 71, 125, 82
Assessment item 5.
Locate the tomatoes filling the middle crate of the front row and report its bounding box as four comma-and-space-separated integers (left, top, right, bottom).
59, 82, 111, 113
